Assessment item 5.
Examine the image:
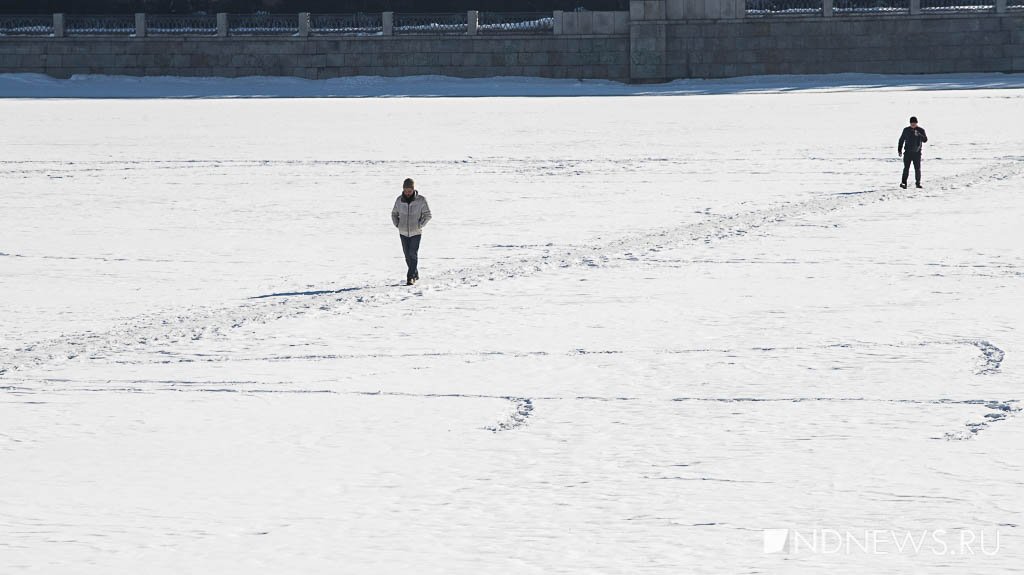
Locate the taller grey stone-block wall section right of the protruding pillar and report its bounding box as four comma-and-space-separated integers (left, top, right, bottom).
665, 13, 1024, 79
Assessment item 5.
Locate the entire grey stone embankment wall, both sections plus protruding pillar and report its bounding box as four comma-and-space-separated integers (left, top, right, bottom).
0, 11, 1024, 82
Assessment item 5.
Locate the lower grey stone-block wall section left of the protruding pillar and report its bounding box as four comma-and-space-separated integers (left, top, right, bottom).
0, 35, 629, 81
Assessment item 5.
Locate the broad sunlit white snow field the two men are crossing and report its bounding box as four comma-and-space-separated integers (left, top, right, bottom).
0, 76, 1024, 575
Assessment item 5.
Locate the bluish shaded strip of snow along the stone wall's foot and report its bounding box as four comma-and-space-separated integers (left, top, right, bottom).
0, 74, 1024, 98
